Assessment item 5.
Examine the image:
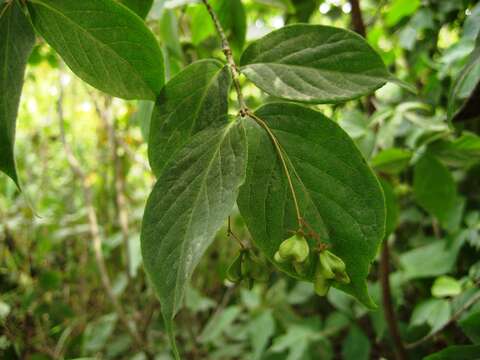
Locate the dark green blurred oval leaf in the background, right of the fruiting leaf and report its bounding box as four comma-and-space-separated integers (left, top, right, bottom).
413, 153, 457, 225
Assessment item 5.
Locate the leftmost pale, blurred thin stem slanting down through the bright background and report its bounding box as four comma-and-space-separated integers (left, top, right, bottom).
57, 72, 145, 349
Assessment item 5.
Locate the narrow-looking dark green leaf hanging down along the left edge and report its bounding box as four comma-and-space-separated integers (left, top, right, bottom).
0, 1, 35, 186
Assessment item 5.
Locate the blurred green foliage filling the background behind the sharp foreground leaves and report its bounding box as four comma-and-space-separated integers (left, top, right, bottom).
0, 0, 480, 360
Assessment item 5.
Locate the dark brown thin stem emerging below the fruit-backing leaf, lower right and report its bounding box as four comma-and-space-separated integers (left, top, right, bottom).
379, 240, 408, 360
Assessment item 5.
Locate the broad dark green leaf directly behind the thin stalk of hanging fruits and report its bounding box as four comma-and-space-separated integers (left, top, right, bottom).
238, 103, 385, 307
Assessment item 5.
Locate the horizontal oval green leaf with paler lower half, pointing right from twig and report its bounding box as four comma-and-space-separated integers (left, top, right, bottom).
241, 25, 390, 103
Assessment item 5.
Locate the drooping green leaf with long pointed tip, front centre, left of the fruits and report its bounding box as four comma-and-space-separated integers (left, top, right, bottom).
141, 121, 246, 334
